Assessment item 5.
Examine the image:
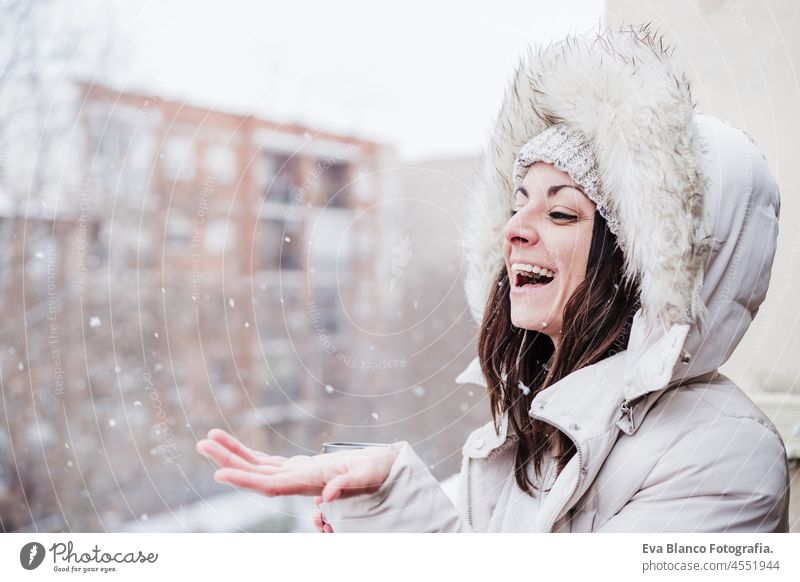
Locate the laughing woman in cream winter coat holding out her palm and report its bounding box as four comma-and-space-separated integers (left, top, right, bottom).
198, 28, 789, 532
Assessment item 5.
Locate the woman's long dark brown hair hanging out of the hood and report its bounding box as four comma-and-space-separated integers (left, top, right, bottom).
478, 211, 639, 495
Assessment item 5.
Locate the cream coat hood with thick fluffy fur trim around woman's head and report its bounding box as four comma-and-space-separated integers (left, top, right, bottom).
462, 27, 780, 398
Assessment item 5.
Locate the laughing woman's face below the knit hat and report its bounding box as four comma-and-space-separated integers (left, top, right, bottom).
503, 162, 595, 346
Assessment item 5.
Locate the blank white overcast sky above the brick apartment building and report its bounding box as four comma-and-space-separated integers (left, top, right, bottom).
81, 0, 604, 159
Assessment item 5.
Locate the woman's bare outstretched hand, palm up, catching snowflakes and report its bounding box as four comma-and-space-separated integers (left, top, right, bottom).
197, 429, 397, 502
